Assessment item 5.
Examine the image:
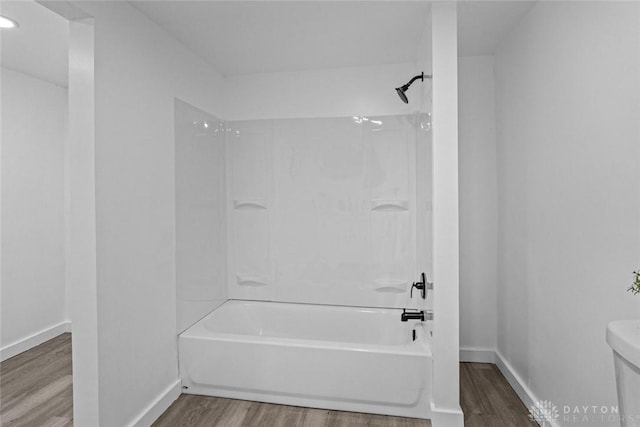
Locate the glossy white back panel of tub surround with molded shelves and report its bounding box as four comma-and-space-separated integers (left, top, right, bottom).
225, 112, 430, 308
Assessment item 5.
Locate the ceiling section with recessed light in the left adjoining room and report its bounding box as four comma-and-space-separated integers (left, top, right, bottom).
0, 0, 69, 87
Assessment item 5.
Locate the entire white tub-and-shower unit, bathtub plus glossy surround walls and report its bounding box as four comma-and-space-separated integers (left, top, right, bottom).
176, 103, 432, 418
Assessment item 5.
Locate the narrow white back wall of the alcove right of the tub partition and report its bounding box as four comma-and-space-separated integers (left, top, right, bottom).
458, 55, 498, 351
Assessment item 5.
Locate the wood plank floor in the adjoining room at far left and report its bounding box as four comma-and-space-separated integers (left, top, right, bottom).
0, 334, 73, 427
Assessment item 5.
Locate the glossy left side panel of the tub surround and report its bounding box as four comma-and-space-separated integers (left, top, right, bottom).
175, 99, 227, 333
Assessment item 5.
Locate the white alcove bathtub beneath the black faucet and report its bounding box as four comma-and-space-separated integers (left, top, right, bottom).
179, 300, 432, 418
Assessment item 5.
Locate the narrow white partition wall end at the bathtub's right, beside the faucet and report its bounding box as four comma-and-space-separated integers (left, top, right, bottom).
431, 1, 464, 427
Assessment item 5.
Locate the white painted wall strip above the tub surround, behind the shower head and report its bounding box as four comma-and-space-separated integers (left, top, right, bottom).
223, 63, 431, 120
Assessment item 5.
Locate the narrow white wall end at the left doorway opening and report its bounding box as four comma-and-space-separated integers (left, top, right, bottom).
67, 18, 99, 426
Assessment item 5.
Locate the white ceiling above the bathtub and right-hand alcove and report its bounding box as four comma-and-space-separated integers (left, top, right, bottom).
130, 0, 534, 76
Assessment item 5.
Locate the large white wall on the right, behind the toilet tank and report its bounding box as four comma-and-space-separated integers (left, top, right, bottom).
495, 2, 640, 425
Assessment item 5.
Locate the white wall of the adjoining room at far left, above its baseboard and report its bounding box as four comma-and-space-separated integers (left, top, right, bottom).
0, 68, 67, 347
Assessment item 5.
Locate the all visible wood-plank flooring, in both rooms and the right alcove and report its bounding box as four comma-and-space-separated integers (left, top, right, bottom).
0, 334, 537, 427
